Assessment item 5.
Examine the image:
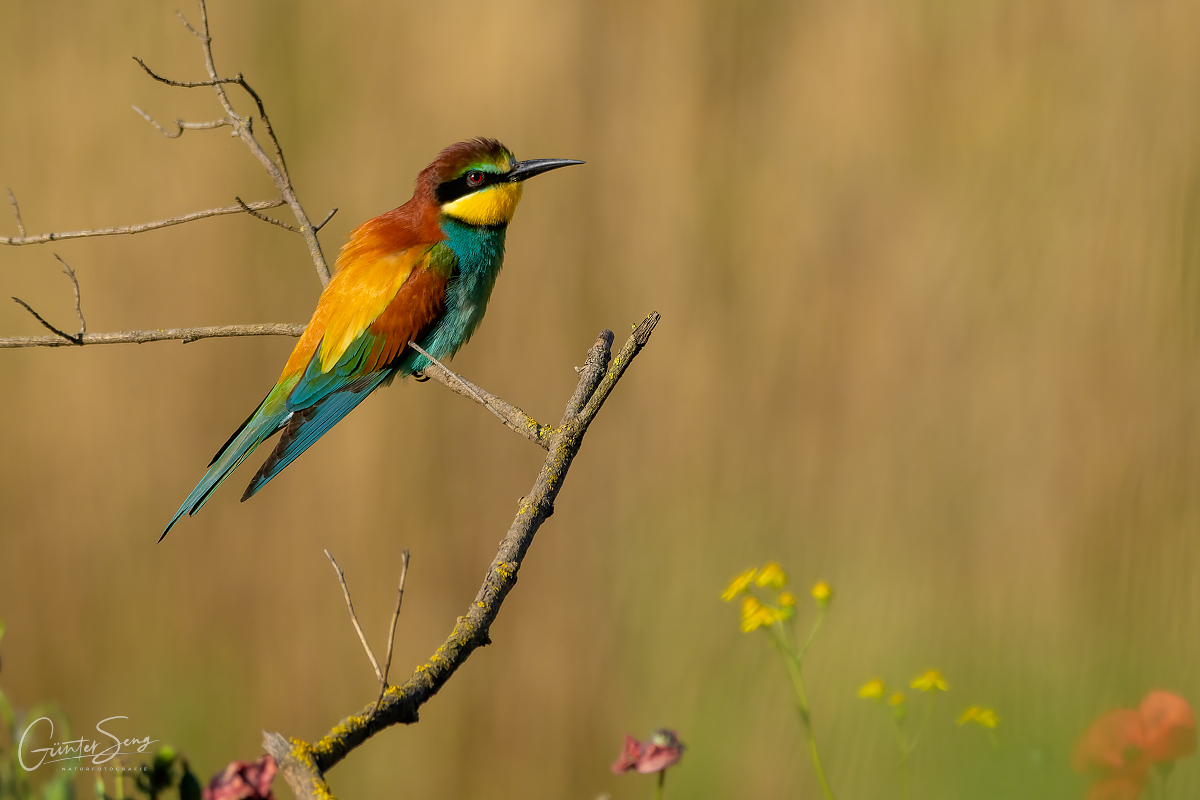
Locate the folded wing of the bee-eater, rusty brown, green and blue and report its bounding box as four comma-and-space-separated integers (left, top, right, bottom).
241, 246, 452, 500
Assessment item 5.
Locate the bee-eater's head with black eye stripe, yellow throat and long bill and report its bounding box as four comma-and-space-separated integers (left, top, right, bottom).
419, 139, 583, 227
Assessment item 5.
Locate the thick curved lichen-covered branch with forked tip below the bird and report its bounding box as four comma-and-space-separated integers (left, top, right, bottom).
263, 313, 659, 799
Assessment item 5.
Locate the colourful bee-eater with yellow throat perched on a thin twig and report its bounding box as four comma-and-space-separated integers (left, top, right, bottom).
158, 138, 583, 542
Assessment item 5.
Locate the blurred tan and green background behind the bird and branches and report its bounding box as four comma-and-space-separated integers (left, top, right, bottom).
0, 0, 1200, 800
